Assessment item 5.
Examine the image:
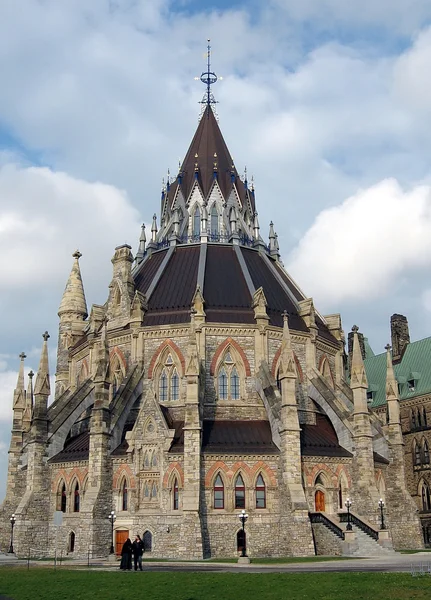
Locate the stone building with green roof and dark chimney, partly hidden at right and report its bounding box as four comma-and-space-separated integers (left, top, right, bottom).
364, 315, 431, 546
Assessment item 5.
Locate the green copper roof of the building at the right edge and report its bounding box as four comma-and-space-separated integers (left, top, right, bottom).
364, 337, 431, 407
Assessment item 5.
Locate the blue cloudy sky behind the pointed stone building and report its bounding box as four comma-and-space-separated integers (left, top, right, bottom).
0, 0, 431, 497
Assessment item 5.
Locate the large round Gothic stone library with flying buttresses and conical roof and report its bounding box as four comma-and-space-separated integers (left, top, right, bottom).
0, 89, 423, 559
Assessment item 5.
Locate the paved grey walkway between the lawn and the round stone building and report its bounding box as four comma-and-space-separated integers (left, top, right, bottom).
0, 552, 431, 574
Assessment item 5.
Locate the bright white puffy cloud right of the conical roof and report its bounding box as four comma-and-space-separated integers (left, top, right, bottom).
287, 179, 431, 305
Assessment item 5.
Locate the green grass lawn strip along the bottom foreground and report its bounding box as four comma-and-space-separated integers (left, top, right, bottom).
0, 567, 431, 600
